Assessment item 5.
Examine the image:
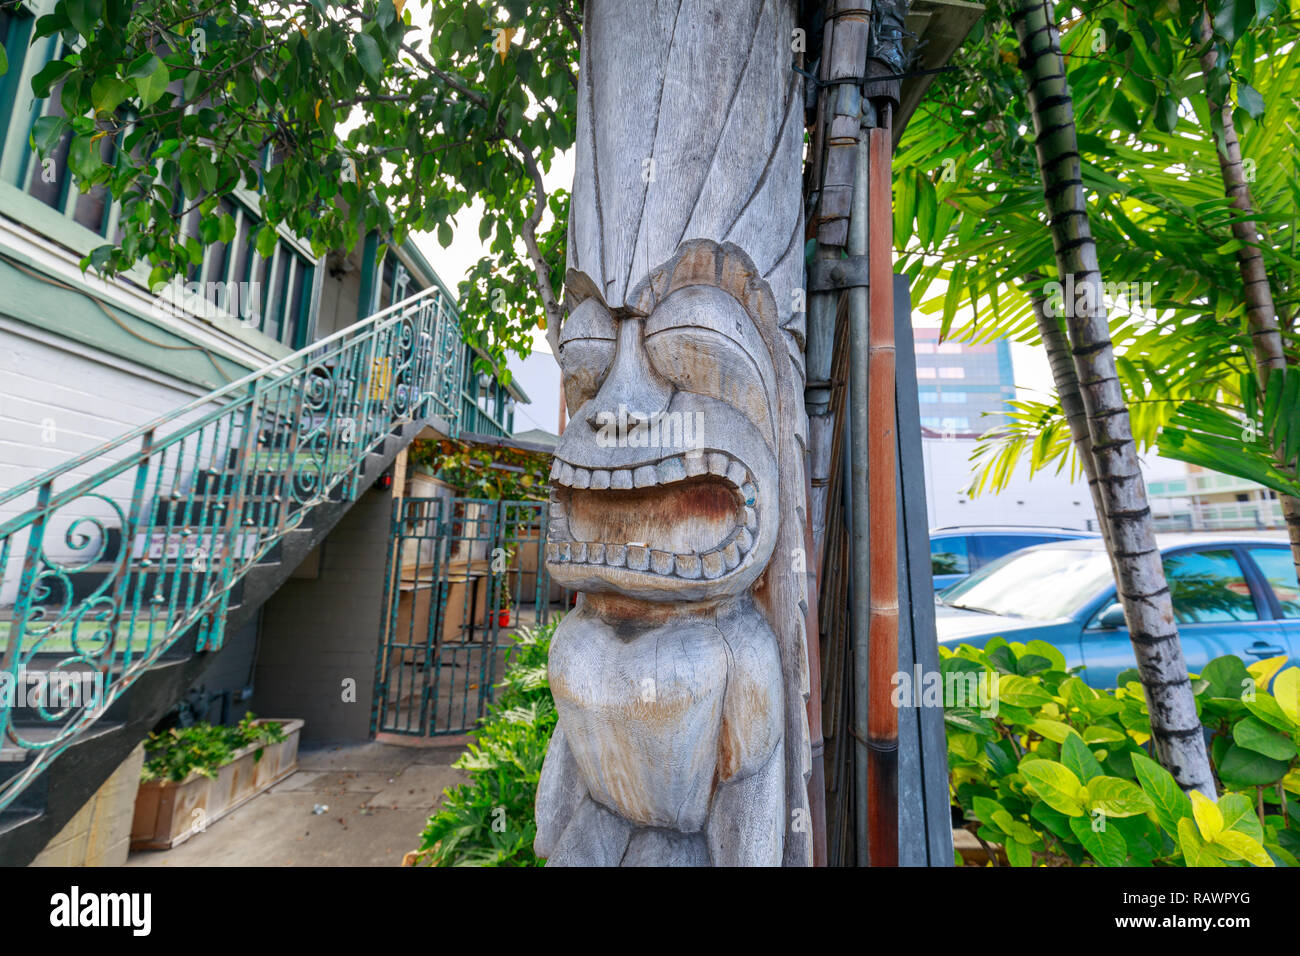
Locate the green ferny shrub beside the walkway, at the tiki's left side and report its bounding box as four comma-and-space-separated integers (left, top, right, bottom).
419, 622, 556, 866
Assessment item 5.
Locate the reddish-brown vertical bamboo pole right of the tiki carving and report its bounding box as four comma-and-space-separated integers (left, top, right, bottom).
866, 104, 898, 866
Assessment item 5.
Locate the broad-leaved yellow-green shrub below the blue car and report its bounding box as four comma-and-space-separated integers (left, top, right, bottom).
940, 639, 1300, 866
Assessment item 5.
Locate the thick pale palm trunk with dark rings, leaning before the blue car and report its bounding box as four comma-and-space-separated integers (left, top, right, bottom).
1011, 0, 1216, 799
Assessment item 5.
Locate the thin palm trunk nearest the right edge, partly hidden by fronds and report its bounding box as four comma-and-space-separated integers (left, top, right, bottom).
1201, 12, 1300, 575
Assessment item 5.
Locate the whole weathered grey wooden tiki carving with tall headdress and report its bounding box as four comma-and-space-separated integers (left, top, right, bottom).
536, 0, 811, 866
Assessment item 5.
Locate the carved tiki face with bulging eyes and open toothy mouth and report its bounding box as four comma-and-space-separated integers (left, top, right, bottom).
546, 241, 780, 601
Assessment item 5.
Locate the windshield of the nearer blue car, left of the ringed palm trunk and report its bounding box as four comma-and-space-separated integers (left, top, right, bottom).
940, 546, 1114, 620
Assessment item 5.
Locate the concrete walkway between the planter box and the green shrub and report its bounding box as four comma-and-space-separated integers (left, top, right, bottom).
126, 741, 465, 866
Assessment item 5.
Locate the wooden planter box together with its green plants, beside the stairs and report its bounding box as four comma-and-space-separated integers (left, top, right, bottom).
131, 714, 303, 849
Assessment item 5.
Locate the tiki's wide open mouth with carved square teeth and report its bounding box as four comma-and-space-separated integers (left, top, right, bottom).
546, 451, 758, 580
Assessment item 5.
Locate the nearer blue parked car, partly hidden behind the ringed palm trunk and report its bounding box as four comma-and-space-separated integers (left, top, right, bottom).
937, 533, 1300, 688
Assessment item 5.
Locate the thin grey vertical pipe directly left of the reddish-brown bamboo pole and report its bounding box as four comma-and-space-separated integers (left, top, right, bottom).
846, 110, 868, 866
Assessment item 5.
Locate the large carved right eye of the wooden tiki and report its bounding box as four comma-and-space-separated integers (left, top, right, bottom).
645, 286, 776, 441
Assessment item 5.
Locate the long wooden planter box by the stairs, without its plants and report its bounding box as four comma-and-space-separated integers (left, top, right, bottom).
131, 718, 303, 849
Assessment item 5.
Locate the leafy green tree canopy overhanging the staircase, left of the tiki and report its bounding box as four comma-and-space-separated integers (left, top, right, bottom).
22, 0, 581, 367
